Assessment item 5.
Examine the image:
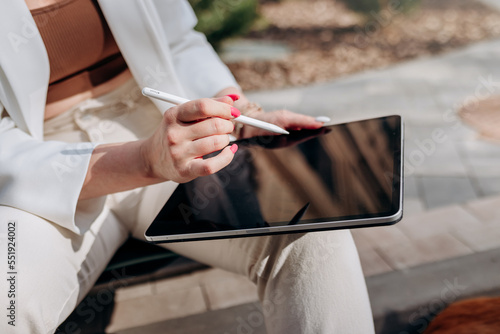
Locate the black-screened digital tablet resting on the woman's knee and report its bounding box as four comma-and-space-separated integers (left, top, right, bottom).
145, 116, 403, 243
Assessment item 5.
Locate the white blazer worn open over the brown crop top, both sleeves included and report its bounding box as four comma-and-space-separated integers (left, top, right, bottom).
0, 0, 238, 234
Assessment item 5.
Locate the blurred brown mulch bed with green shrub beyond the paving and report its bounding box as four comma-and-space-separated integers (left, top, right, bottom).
190, 0, 500, 90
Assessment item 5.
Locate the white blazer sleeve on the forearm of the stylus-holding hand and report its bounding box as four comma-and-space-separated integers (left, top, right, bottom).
0, 103, 105, 234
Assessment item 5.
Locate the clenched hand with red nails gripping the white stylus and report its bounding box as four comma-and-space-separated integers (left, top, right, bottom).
141, 96, 240, 183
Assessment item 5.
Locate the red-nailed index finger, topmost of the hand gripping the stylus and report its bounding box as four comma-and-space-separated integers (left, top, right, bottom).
177, 97, 241, 123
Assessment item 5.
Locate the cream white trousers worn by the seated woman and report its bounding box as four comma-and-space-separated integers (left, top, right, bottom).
0, 81, 374, 334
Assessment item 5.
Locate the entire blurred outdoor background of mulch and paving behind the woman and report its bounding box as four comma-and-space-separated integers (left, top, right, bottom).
63, 0, 500, 334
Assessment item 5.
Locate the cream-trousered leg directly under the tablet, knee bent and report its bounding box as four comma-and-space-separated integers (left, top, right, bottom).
129, 184, 373, 334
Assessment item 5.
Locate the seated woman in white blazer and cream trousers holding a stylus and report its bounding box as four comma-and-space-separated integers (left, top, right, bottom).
0, 0, 373, 333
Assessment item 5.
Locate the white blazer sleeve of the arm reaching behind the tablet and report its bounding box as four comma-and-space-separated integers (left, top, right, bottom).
155, 0, 240, 99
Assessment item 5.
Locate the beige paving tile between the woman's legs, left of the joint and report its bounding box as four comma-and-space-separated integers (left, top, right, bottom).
106, 286, 208, 333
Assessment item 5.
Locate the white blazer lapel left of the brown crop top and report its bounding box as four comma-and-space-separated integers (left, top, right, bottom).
0, 1, 50, 139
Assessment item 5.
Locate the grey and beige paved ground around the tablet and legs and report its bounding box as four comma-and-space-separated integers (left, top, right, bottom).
75, 35, 500, 333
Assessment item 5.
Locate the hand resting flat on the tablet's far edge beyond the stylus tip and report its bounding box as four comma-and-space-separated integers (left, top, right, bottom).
240, 110, 324, 138
